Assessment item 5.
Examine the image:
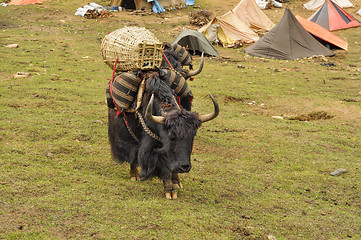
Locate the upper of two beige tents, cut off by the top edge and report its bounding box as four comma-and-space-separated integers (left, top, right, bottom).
232, 0, 275, 31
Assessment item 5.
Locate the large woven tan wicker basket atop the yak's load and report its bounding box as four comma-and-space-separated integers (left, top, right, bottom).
101, 27, 163, 72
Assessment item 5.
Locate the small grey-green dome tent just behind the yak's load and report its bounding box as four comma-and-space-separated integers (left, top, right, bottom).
173, 29, 219, 56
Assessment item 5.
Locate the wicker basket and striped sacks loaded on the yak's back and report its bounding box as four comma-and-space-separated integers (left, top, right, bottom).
101, 27, 203, 112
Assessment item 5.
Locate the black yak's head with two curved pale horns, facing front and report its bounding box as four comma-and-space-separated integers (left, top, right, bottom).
145, 95, 219, 173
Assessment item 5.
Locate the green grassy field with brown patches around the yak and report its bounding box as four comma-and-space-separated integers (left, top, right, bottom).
0, 0, 361, 240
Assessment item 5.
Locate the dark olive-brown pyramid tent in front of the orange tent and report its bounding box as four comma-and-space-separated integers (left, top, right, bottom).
244, 8, 334, 60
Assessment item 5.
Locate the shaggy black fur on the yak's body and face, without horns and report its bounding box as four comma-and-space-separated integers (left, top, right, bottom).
108, 71, 201, 181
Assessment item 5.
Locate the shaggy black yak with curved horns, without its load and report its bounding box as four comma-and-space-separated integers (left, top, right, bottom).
108, 71, 219, 199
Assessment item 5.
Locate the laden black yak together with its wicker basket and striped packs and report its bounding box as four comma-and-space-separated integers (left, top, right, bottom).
101, 27, 219, 199
